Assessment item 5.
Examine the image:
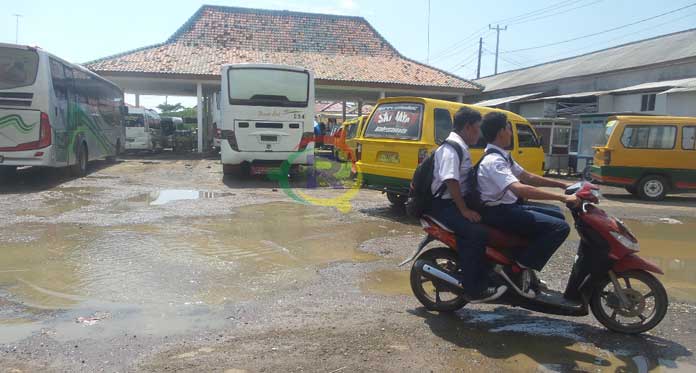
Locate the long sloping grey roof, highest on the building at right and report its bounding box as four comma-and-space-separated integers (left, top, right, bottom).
475, 29, 696, 93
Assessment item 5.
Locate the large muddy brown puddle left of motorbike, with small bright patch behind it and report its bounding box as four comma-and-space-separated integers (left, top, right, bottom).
0, 202, 409, 343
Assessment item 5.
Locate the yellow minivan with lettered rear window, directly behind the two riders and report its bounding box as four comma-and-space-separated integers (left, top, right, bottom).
356, 97, 544, 204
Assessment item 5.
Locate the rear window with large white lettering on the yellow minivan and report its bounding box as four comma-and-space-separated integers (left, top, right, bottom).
365, 104, 423, 140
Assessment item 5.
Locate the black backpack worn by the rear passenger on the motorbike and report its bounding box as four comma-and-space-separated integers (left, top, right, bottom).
406, 140, 464, 218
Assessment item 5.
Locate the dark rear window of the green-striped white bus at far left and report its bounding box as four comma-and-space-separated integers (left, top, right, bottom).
0, 47, 39, 89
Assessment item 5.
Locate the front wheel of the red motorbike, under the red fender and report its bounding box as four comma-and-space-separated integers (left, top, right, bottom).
590, 271, 669, 334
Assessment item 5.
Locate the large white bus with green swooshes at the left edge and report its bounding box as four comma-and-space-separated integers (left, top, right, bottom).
0, 43, 127, 176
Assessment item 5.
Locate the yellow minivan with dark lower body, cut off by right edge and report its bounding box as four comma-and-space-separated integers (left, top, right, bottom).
591, 116, 696, 201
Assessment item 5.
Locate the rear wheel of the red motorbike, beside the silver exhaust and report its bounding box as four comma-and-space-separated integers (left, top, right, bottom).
411, 247, 468, 312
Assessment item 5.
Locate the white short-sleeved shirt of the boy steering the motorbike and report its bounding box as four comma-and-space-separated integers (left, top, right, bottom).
477, 144, 524, 206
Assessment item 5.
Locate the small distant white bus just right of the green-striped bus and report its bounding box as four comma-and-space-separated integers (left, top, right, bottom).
126, 107, 164, 152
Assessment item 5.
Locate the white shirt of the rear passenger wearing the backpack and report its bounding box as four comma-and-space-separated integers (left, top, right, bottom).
430, 132, 472, 199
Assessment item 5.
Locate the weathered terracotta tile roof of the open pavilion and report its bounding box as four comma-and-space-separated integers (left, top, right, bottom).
87, 5, 481, 90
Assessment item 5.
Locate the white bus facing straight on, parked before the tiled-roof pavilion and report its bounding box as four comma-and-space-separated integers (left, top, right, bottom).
220, 64, 314, 174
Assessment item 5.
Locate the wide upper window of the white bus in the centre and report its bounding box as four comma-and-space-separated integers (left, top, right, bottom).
227, 68, 309, 107
